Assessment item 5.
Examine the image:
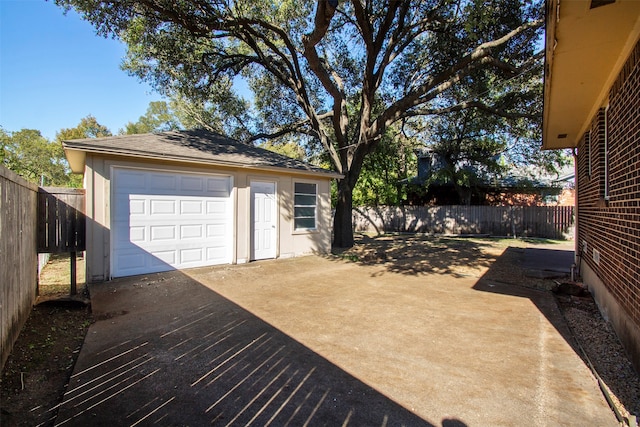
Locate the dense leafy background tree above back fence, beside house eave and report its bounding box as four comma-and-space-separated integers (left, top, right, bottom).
411, 56, 571, 204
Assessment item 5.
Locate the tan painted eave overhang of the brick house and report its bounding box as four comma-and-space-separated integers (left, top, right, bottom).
542, 0, 640, 149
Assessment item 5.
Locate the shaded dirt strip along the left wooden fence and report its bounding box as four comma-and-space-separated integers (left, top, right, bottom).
0, 255, 91, 427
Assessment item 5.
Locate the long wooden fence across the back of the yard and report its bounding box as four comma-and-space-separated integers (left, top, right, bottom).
353, 206, 574, 239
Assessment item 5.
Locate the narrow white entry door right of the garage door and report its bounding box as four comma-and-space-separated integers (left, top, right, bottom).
251, 181, 278, 260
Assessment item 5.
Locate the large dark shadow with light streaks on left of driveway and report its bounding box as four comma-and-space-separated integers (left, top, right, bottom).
56, 272, 464, 426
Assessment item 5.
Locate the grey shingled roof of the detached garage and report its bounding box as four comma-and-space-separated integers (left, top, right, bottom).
62, 130, 342, 178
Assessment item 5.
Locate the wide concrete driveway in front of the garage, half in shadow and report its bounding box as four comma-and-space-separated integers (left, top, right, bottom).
56, 248, 617, 427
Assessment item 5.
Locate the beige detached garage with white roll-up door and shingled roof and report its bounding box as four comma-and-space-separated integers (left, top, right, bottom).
63, 131, 340, 282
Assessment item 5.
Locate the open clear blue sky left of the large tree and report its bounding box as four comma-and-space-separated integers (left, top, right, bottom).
0, 0, 161, 139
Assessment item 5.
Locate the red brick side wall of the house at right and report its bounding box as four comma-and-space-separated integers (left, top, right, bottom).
576, 37, 640, 372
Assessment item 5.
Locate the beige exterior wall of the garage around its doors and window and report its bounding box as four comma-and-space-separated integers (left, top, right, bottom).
84, 153, 331, 282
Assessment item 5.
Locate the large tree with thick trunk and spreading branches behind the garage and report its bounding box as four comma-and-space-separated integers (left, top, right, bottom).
56, 0, 543, 247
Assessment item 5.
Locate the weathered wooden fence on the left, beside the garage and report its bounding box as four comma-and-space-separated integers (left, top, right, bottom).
0, 169, 86, 367
